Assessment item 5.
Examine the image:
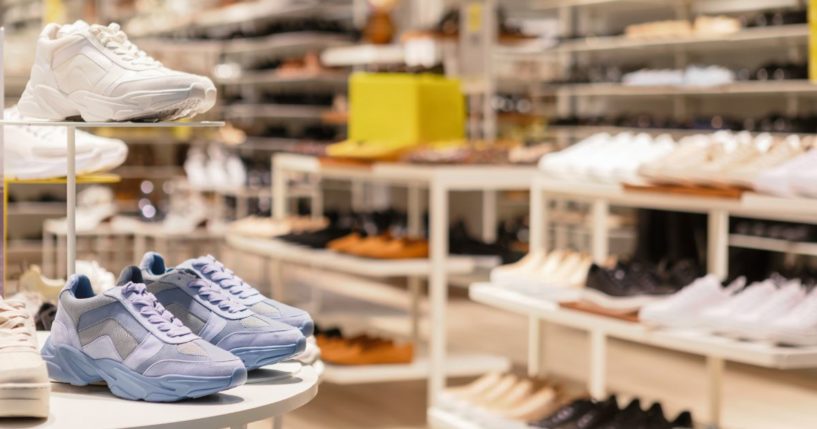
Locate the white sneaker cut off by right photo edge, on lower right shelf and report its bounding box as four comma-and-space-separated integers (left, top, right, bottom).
762, 289, 817, 346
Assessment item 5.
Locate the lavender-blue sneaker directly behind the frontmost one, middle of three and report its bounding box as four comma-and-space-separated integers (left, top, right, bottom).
124, 253, 306, 370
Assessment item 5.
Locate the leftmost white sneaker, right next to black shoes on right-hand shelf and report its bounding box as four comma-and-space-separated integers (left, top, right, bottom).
638, 274, 746, 329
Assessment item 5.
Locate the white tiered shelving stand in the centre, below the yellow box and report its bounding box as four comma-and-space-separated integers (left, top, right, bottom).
227, 154, 535, 397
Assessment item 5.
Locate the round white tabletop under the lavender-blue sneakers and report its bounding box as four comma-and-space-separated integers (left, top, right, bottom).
0, 335, 318, 429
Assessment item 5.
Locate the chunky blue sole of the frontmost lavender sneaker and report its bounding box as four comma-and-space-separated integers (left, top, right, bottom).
42, 339, 247, 402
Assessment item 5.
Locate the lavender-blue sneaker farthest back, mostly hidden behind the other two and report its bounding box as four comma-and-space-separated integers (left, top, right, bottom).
148, 254, 315, 337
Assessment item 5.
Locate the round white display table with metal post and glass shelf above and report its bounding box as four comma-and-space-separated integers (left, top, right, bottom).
0, 56, 318, 429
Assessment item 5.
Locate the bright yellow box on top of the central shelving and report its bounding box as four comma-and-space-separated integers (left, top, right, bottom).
349, 73, 465, 144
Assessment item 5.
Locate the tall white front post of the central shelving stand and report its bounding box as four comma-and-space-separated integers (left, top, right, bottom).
428, 180, 448, 406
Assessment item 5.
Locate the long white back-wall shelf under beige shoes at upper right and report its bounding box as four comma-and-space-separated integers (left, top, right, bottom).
552, 24, 809, 52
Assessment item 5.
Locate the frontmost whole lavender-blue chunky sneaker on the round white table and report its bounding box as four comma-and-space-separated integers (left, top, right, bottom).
42, 275, 247, 402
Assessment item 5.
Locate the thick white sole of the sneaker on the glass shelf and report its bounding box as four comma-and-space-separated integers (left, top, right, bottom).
18, 82, 216, 122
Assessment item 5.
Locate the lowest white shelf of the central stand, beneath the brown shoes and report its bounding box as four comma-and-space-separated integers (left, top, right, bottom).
323, 354, 511, 384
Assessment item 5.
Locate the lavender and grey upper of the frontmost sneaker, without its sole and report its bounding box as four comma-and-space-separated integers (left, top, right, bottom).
50, 275, 241, 377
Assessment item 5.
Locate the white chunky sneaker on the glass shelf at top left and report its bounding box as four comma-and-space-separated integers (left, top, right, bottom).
19, 21, 216, 121
